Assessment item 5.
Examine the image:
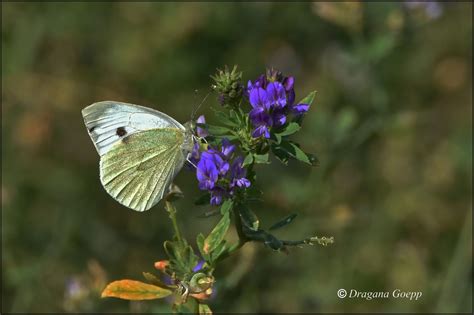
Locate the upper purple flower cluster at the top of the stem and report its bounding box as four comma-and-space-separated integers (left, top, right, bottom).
246, 71, 309, 138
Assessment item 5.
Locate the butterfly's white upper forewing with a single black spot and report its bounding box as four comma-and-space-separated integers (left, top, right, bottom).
82, 101, 185, 156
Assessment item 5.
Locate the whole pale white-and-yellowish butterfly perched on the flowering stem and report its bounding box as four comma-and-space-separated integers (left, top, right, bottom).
82, 101, 194, 211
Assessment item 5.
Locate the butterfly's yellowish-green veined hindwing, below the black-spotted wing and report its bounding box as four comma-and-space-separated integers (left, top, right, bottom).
100, 127, 186, 211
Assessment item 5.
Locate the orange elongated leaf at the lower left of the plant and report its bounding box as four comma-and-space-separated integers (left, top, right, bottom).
102, 280, 172, 300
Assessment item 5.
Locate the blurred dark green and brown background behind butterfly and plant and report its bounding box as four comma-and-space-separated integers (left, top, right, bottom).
2, 2, 472, 313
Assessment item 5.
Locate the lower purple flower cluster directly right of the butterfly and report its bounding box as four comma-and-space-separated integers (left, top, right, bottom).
192, 139, 250, 205
